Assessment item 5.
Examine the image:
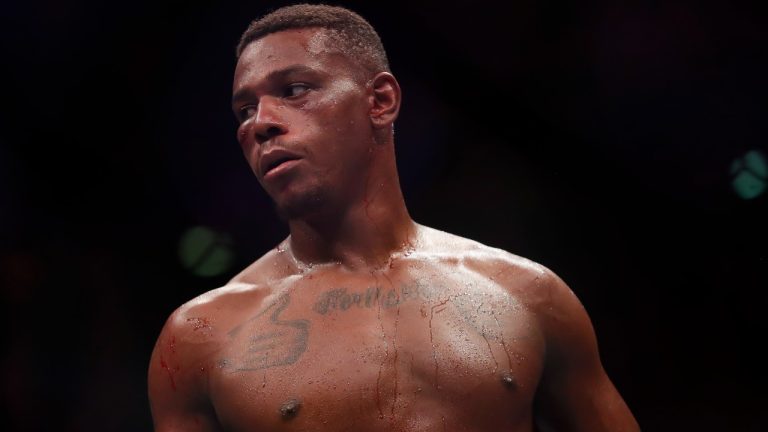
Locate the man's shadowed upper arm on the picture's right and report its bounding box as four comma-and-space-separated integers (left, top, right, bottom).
535, 270, 639, 432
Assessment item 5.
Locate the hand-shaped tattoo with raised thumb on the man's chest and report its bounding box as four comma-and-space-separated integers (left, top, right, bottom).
229, 294, 309, 371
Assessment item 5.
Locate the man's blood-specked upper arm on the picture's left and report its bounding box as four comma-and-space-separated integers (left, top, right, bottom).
148, 311, 220, 432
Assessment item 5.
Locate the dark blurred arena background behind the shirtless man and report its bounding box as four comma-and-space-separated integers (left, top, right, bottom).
0, 0, 768, 431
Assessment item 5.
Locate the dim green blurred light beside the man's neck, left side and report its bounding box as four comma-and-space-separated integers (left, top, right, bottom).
179, 226, 235, 277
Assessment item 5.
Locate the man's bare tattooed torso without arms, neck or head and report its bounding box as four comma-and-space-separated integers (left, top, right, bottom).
169, 228, 544, 431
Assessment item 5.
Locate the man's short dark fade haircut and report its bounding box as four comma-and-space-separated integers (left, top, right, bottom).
235, 4, 391, 73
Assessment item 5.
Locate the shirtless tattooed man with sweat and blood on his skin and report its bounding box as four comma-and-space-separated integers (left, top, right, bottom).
149, 5, 638, 432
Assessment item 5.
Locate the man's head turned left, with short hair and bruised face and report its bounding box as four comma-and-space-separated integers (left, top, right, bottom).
232, 5, 400, 219
